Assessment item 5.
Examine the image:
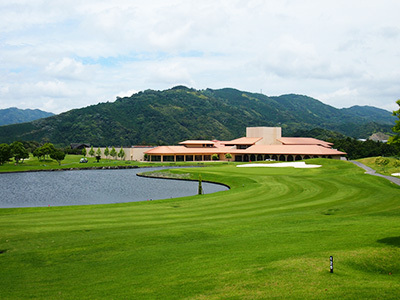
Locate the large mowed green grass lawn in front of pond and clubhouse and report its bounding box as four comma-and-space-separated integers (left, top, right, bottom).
0, 159, 400, 299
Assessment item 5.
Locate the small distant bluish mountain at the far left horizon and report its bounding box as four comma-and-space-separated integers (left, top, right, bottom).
0, 107, 54, 126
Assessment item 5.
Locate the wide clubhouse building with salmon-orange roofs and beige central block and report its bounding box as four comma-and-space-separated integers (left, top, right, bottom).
144, 127, 346, 162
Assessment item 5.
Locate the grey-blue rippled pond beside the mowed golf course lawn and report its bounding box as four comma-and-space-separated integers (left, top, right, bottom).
0, 168, 228, 208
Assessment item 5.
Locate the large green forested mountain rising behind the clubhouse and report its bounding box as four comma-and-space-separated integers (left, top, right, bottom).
0, 86, 394, 146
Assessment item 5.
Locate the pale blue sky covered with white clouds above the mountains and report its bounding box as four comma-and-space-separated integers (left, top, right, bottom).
0, 0, 400, 113
